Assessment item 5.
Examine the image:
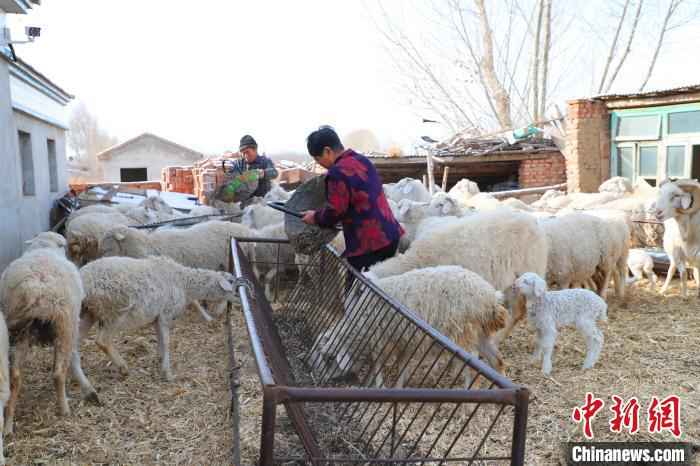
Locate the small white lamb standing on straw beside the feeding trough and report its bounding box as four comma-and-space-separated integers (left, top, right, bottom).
513, 272, 608, 375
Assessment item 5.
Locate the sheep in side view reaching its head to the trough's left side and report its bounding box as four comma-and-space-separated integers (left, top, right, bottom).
80, 256, 243, 381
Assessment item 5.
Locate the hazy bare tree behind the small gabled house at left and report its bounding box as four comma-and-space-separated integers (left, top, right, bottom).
68, 102, 118, 181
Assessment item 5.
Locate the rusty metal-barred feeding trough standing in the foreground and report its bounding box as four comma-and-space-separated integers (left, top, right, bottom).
229, 238, 529, 466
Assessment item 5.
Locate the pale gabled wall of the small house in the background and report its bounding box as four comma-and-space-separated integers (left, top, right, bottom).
99, 137, 201, 183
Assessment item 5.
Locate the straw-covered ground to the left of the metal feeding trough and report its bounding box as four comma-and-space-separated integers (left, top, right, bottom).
5, 306, 241, 465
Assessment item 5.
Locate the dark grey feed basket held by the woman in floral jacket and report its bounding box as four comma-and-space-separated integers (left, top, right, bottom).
268, 176, 340, 255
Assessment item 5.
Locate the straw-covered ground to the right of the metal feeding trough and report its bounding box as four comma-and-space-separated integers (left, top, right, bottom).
501, 280, 700, 465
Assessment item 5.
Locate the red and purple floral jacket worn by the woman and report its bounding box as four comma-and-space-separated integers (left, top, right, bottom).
314, 149, 404, 257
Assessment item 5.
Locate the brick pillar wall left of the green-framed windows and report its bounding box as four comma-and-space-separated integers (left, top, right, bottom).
566, 99, 610, 192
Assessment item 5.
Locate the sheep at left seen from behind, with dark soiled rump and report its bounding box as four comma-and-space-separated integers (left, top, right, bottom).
0, 232, 98, 433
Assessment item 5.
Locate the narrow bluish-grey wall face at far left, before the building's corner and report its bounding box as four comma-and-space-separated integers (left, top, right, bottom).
0, 59, 22, 271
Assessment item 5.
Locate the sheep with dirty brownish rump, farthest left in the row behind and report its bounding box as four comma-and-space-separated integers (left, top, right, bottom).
66, 212, 136, 266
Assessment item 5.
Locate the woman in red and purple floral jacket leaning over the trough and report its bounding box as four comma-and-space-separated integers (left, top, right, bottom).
303, 126, 404, 271
